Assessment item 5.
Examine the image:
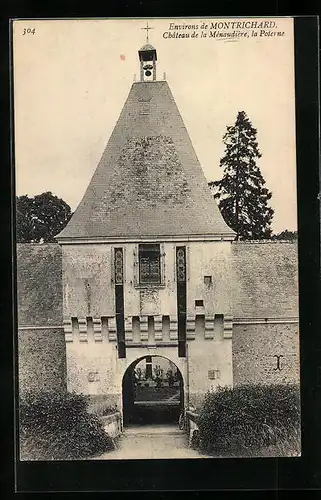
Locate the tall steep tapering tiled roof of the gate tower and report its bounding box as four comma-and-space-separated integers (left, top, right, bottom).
58, 81, 235, 242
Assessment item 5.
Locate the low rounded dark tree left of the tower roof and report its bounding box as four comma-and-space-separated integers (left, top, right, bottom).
16, 191, 72, 243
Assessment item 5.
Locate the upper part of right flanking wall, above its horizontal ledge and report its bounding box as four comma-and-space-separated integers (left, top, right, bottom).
232, 240, 299, 318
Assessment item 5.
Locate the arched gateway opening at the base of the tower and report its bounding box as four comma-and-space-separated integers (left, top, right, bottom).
122, 356, 184, 426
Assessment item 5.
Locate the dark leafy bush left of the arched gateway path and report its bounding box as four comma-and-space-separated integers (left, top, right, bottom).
19, 392, 114, 460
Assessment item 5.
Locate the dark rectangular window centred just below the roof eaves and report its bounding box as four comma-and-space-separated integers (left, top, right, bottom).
138, 243, 161, 285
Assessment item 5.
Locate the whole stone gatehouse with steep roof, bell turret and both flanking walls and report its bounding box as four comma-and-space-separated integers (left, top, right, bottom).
18, 40, 299, 422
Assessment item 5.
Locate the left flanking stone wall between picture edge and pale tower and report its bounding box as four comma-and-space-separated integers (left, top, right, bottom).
16, 243, 66, 394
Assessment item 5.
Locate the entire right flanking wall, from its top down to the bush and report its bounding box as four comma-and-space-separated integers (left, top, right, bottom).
232, 241, 300, 384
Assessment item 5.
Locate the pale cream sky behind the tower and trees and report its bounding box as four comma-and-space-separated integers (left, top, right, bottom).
13, 18, 297, 233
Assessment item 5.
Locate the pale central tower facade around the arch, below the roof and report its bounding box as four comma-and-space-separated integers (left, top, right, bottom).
62, 241, 232, 407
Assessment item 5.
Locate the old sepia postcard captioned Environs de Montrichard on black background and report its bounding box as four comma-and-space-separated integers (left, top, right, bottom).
13, 17, 301, 461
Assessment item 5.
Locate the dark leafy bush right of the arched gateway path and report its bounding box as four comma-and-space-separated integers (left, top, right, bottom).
197, 384, 300, 456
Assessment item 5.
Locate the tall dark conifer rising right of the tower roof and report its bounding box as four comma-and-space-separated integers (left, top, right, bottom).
209, 111, 274, 240
